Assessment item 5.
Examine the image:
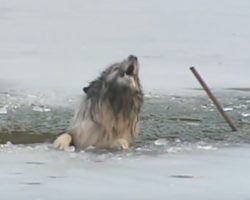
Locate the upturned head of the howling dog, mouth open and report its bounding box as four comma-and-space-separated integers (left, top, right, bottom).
83, 55, 141, 96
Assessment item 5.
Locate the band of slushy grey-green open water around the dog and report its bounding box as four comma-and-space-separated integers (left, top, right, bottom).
0, 90, 250, 146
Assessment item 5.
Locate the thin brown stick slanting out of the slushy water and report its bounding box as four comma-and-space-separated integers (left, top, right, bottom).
190, 67, 237, 131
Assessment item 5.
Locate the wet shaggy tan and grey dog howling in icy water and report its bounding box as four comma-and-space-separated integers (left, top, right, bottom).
54, 55, 143, 150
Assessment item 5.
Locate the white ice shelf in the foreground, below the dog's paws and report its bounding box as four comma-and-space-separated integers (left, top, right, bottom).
0, 146, 250, 200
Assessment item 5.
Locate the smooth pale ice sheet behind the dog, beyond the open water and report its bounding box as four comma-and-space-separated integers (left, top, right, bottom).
0, 0, 250, 92
